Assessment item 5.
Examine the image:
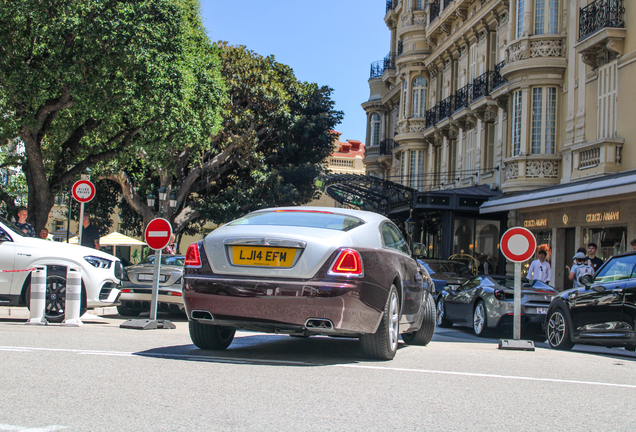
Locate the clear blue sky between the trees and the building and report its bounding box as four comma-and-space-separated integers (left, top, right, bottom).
200, 0, 390, 142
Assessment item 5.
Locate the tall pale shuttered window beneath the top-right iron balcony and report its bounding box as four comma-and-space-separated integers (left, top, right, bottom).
596, 60, 618, 138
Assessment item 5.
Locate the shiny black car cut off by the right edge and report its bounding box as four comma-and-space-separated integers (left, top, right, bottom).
546, 252, 636, 351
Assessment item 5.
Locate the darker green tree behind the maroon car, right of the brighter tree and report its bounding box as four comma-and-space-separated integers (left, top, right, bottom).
105, 43, 342, 234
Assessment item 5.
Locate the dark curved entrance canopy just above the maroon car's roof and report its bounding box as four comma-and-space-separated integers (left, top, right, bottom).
316, 174, 417, 216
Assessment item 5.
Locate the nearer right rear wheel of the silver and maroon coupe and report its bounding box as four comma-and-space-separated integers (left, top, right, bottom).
360, 285, 400, 360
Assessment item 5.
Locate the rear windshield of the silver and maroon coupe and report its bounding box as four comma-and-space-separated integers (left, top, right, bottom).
230, 210, 365, 231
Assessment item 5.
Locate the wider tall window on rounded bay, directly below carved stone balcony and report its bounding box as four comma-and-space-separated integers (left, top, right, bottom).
532, 87, 557, 154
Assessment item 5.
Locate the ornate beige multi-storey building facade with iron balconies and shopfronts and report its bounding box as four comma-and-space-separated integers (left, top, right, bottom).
362, 0, 636, 288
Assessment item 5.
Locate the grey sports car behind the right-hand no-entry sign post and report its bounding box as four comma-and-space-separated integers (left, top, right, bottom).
437, 275, 556, 336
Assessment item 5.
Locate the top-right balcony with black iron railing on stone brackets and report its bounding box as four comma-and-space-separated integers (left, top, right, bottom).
574, 0, 627, 68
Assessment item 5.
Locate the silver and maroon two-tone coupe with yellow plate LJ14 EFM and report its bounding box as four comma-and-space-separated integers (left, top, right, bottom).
183, 207, 435, 360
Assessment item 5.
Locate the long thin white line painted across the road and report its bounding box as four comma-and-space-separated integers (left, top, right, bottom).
0, 346, 636, 390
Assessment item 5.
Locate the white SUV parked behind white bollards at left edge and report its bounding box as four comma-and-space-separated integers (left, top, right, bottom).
0, 218, 123, 322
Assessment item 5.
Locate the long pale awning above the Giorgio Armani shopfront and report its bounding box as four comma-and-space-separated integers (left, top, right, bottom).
479, 170, 636, 213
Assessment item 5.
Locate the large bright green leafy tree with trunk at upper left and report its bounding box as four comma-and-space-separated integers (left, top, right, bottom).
0, 0, 224, 230
